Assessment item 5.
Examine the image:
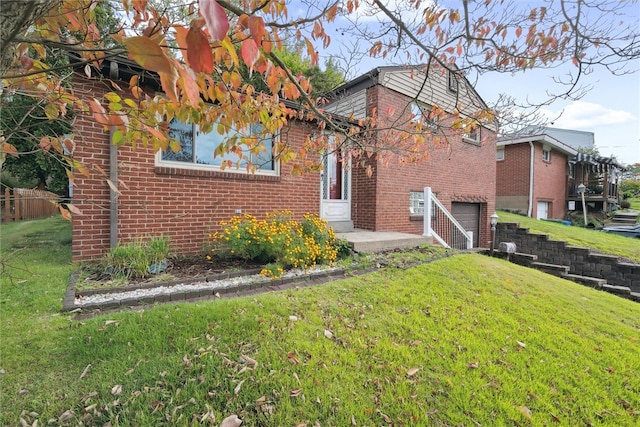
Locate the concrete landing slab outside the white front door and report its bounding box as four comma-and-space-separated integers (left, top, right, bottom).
336, 230, 433, 252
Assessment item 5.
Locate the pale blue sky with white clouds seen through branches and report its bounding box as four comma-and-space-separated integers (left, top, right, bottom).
296, 0, 640, 165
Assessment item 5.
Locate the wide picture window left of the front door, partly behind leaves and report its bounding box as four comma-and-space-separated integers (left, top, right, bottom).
160, 118, 276, 174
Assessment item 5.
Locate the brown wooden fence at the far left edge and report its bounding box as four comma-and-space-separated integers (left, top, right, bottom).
0, 188, 58, 222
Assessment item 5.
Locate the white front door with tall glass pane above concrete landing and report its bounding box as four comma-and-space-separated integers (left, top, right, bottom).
320, 152, 351, 222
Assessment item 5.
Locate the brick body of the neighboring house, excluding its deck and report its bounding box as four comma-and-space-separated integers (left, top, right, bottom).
496, 134, 577, 219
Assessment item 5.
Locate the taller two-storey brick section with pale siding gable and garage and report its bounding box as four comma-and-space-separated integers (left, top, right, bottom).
328, 67, 496, 247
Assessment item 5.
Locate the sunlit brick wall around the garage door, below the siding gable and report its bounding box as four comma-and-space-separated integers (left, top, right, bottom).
368, 86, 496, 246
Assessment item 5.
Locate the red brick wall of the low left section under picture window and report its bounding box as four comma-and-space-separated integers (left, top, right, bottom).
73, 77, 320, 261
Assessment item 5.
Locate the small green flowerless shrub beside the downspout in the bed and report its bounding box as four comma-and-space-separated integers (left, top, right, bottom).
105, 236, 169, 278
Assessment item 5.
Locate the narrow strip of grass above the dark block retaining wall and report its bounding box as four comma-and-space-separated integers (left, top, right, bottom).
498, 211, 640, 262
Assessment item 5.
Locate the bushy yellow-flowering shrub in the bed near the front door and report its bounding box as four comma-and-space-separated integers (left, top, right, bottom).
208, 211, 337, 277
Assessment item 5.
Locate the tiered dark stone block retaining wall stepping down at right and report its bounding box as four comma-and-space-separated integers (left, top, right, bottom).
496, 223, 640, 292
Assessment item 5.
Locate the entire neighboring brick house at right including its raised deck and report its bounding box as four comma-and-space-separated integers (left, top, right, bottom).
496, 133, 624, 219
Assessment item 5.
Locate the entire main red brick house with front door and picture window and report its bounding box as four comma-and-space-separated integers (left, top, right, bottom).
72, 60, 496, 261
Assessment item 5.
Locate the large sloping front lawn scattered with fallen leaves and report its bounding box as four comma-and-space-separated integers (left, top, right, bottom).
0, 218, 640, 426
